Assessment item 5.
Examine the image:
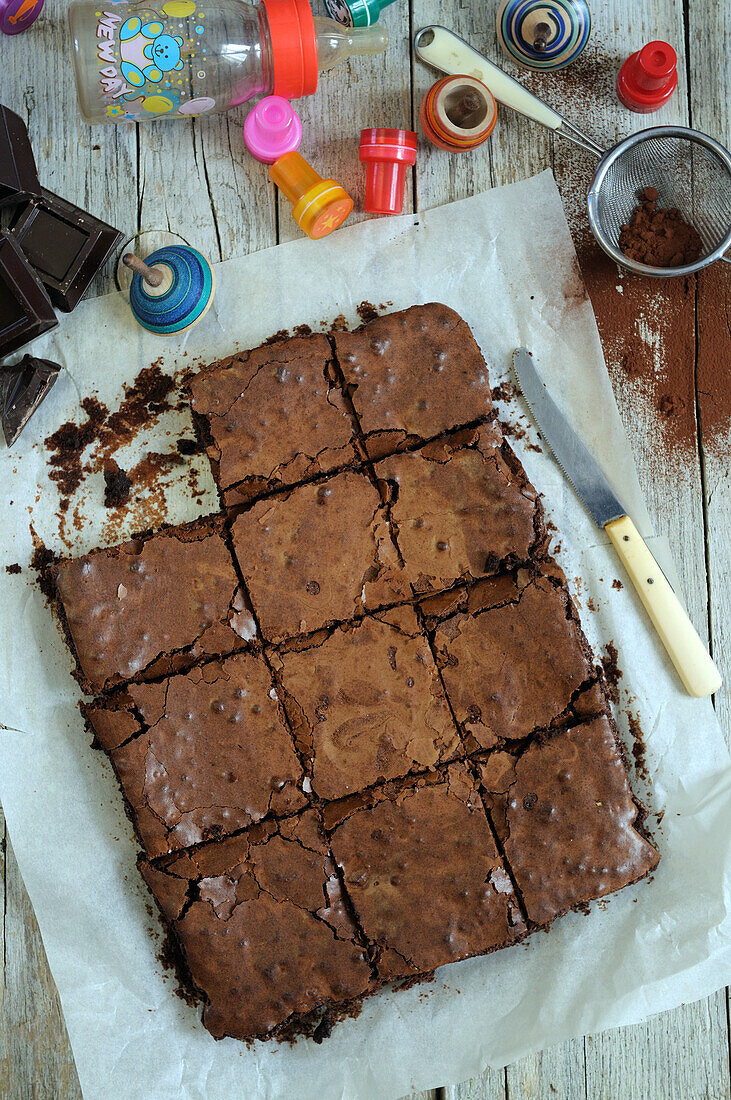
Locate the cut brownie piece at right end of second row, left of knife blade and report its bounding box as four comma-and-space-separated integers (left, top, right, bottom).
376, 424, 543, 594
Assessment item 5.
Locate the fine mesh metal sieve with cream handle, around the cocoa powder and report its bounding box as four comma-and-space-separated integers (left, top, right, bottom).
414, 26, 731, 278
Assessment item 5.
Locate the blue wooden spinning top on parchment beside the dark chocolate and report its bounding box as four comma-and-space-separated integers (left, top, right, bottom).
122, 244, 215, 336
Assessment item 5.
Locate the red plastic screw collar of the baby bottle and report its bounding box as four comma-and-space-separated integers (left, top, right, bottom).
264, 0, 318, 99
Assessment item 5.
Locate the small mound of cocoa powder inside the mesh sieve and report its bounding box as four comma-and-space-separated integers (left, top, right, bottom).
619, 187, 704, 267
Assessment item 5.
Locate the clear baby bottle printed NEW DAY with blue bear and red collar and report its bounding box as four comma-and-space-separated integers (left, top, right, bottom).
68, 0, 388, 123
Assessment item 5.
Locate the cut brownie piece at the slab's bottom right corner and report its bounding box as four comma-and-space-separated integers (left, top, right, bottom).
478, 716, 660, 924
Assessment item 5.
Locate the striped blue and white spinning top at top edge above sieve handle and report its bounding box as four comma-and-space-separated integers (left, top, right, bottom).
497, 0, 591, 72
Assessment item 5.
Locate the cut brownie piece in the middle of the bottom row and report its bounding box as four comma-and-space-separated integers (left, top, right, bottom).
331, 763, 524, 979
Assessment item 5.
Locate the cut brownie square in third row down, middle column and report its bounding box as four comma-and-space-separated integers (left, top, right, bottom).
273, 607, 461, 799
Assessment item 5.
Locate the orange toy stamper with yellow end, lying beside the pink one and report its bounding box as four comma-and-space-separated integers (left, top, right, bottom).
269, 153, 353, 241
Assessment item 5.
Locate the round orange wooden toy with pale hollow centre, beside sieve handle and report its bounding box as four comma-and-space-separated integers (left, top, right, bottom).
419, 76, 498, 153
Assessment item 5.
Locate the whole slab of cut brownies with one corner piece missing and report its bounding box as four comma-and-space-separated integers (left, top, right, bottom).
55, 305, 658, 1038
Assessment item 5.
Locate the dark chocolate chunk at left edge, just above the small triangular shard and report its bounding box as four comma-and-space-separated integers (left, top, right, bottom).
0, 232, 58, 359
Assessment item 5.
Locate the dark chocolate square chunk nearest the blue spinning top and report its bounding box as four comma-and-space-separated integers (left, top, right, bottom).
11, 188, 122, 312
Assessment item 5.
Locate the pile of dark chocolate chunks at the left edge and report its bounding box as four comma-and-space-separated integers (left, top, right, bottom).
0, 105, 122, 447
